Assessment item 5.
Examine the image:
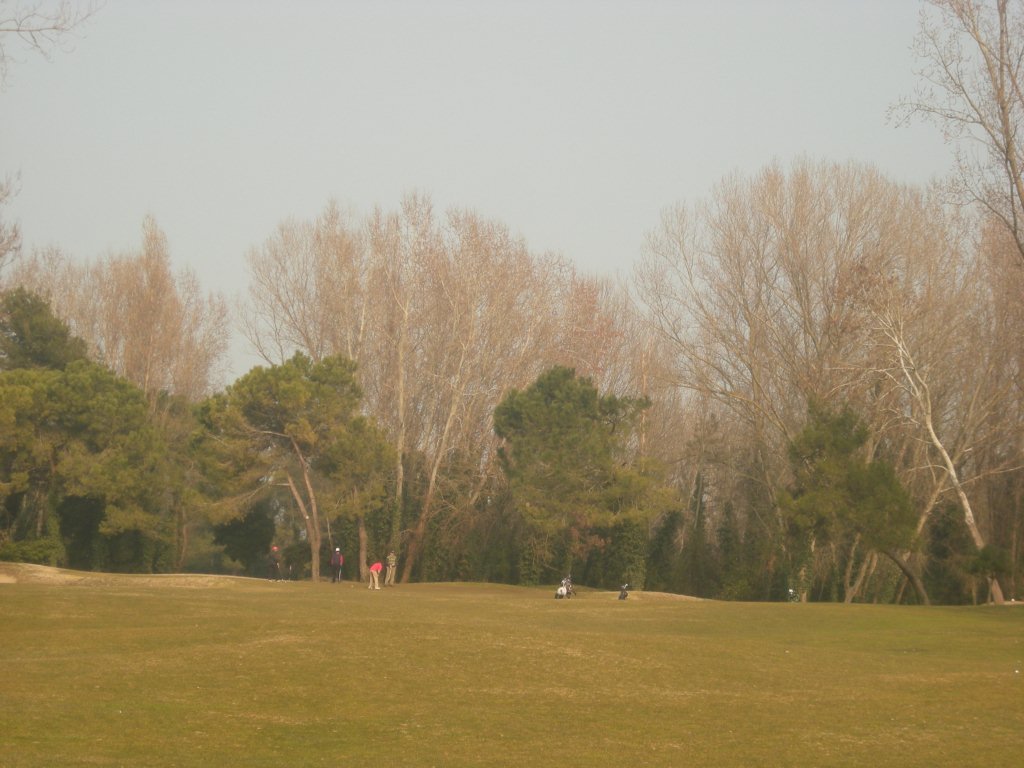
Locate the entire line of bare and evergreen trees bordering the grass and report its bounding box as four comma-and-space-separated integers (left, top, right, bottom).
0, 0, 1024, 603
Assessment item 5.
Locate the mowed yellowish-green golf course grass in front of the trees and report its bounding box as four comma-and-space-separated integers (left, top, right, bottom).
0, 564, 1024, 768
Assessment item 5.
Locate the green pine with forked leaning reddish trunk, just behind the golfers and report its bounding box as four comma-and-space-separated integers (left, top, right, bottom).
198, 352, 391, 581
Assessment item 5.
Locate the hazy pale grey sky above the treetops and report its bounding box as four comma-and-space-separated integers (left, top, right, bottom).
0, 0, 950, 373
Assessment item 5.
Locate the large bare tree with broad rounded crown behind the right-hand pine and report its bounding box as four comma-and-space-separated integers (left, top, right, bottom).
637, 161, 974, 590
